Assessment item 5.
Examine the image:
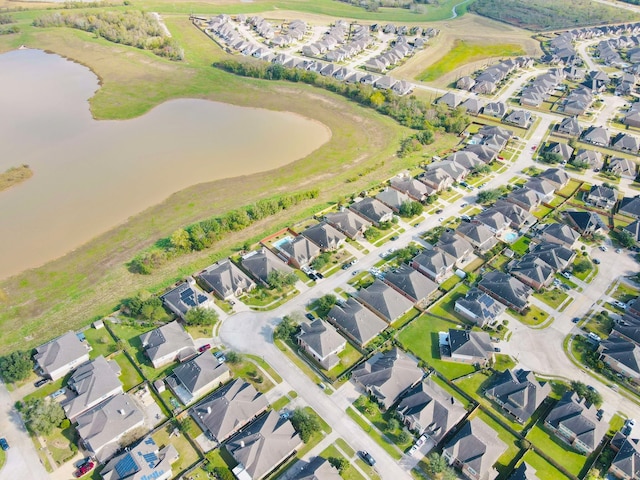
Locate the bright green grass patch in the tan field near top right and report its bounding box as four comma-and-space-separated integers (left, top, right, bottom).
417, 40, 525, 82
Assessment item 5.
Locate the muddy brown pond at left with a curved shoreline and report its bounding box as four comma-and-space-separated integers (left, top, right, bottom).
0, 50, 331, 278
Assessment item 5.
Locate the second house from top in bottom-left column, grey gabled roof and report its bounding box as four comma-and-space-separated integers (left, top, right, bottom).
62, 355, 122, 422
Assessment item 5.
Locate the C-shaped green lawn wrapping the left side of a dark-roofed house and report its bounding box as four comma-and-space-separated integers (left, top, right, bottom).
398, 313, 475, 379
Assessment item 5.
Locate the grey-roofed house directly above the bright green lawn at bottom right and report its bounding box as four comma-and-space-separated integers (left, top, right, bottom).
544, 392, 608, 454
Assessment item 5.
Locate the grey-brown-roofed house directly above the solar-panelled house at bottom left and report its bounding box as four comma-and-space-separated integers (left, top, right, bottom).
76, 393, 144, 463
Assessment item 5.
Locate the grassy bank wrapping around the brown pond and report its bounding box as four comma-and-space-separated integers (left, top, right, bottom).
0, 11, 464, 353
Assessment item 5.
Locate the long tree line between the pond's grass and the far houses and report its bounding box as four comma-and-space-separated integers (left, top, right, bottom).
213, 58, 469, 133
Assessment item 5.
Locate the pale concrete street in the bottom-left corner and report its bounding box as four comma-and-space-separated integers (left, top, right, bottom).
0, 382, 49, 480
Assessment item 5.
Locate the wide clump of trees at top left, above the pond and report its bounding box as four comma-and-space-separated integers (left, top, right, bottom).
33, 10, 184, 61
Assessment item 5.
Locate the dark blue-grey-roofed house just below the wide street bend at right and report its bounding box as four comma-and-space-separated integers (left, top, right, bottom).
485, 370, 551, 424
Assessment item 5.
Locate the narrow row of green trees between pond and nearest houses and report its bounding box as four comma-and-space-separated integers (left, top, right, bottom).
127, 189, 319, 275
